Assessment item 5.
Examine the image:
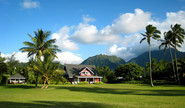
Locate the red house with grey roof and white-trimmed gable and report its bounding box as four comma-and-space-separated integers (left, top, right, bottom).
64, 64, 103, 84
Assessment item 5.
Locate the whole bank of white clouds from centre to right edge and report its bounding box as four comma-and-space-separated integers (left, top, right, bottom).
54, 9, 185, 61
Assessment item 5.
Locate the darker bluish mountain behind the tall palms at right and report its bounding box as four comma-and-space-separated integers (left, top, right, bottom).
127, 49, 185, 67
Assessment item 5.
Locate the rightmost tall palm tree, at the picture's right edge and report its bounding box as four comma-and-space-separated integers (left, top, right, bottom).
170, 24, 185, 84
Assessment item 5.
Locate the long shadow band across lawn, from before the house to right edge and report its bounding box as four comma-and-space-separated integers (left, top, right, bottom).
56, 86, 185, 96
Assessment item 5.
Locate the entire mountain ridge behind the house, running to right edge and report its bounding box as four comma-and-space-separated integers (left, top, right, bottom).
81, 49, 185, 70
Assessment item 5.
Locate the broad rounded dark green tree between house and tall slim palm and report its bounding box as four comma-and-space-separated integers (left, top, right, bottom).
115, 63, 144, 81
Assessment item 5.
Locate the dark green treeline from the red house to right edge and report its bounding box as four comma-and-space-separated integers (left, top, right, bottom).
97, 58, 185, 84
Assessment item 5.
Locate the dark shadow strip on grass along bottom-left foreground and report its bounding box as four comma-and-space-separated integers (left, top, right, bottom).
0, 101, 113, 108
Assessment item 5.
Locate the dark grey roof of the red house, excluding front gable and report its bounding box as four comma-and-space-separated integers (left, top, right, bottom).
64, 64, 101, 78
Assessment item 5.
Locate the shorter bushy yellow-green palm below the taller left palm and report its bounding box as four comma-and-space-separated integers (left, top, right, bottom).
33, 54, 60, 88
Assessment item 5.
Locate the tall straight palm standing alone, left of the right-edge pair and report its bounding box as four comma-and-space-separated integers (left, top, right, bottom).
140, 24, 161, 87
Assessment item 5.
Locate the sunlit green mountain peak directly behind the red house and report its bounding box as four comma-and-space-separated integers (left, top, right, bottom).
81, 54, 126, 70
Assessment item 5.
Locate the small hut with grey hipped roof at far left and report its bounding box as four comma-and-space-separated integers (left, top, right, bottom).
8, 73, 26, 84
